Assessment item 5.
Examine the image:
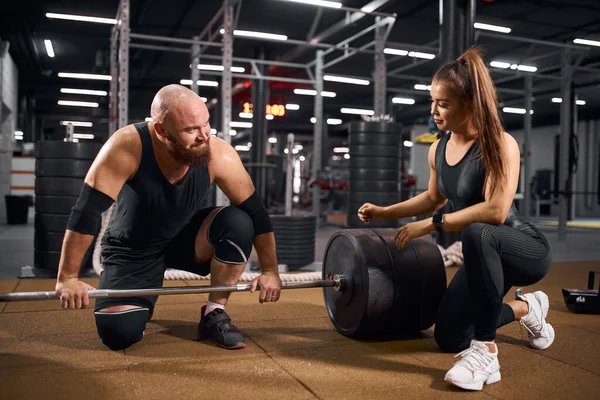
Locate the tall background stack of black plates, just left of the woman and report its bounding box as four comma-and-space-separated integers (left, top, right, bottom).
348, 121, 402, 228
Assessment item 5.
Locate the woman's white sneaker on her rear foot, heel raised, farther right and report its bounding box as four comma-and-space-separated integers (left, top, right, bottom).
517, 289, 554, 350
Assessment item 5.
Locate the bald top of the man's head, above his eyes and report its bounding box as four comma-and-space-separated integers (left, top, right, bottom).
150, 84, 208, 123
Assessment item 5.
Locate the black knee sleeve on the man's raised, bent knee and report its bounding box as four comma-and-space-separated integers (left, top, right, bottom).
208, 206, 254, 264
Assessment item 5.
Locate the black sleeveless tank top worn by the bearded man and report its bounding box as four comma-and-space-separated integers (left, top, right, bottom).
102, 122, 211, 265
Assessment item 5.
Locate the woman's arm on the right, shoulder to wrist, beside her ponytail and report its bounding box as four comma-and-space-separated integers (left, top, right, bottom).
436, 132, 521, 232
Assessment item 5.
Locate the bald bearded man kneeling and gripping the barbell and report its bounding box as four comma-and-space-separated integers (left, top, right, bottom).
56, 85, 281, 350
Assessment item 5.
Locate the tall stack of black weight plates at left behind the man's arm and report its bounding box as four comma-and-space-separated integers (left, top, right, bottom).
34, 140, 102, 270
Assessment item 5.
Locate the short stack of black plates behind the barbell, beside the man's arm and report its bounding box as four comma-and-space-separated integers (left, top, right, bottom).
271, 215, 317, 270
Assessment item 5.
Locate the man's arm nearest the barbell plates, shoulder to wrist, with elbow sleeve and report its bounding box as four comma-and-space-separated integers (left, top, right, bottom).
210, 137, 279, 275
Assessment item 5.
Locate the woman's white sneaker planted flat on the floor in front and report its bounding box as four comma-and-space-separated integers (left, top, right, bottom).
444, 340, 501, 390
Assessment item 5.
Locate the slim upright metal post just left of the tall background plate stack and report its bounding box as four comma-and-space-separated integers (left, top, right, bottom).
314, 50, 324, 229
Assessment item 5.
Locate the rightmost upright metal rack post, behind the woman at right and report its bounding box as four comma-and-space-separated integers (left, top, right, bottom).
554, 48, 572, 241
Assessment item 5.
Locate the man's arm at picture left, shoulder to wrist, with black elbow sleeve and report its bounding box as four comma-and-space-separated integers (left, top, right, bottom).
57, 128, 141, 283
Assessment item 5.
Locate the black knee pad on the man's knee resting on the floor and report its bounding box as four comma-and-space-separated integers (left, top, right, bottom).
94, 308, 150, 350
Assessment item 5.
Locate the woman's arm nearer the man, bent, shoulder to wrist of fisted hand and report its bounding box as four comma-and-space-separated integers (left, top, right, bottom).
383, 140, 447, 219
